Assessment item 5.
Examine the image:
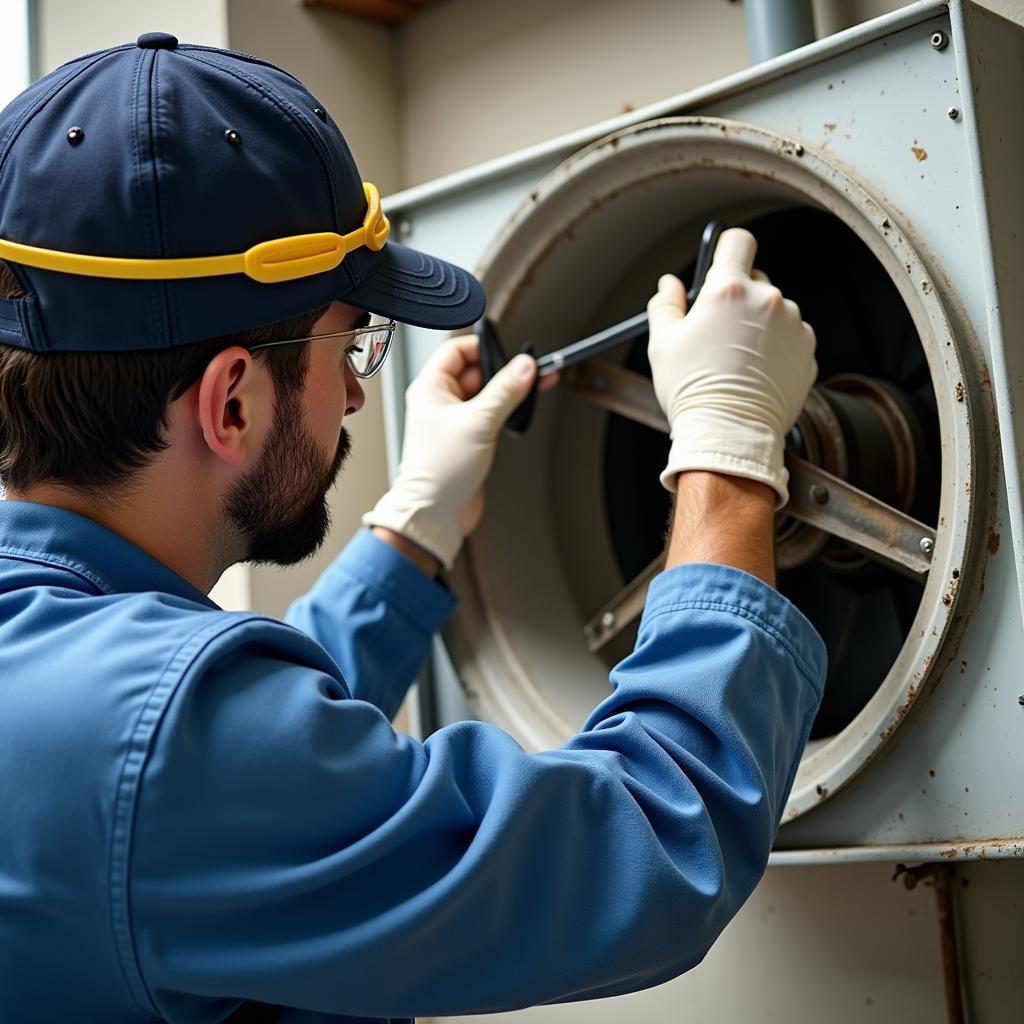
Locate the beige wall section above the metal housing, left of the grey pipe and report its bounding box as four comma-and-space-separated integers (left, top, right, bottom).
399, 0, 746, 184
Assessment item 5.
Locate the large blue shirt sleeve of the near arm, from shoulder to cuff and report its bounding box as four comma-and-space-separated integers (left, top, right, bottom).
131, 565, 824, 1020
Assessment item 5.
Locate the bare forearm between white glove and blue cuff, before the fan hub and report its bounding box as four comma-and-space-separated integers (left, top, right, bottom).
666, 471, 775, 587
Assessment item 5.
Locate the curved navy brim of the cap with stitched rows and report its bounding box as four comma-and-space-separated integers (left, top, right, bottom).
341, 242, 486, 331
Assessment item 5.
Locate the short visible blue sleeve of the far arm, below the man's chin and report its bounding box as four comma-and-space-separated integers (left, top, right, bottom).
286, 529, 455, 719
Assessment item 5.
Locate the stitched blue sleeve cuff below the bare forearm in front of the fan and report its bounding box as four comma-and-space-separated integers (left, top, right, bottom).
640, 563, 827, 695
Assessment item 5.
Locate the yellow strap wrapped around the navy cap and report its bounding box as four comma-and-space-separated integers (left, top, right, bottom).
0, 181, 391, 285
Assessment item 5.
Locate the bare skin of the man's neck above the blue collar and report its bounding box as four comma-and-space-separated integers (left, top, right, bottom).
7, 470, 234, 594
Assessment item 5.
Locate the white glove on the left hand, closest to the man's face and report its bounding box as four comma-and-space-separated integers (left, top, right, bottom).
362, 335, 537, 568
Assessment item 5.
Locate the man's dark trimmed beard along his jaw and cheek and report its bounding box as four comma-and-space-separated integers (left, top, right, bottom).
225, 394, 351, 565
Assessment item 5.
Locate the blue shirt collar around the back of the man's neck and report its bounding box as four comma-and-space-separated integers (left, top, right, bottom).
0, 501, 217, 608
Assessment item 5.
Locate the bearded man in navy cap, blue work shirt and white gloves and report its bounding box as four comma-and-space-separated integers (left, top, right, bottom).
0, 33, 823, 1024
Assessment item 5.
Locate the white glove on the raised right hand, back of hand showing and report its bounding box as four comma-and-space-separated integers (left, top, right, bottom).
647, 227, 818, 508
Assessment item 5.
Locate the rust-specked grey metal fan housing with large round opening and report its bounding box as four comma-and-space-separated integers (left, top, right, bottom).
386, 2, 1024, 861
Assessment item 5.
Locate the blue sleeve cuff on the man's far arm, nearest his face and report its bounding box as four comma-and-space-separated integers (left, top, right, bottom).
335, 529, 456, 634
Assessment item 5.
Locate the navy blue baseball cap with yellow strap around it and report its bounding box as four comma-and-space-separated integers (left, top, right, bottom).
0, 32, 484, 351
